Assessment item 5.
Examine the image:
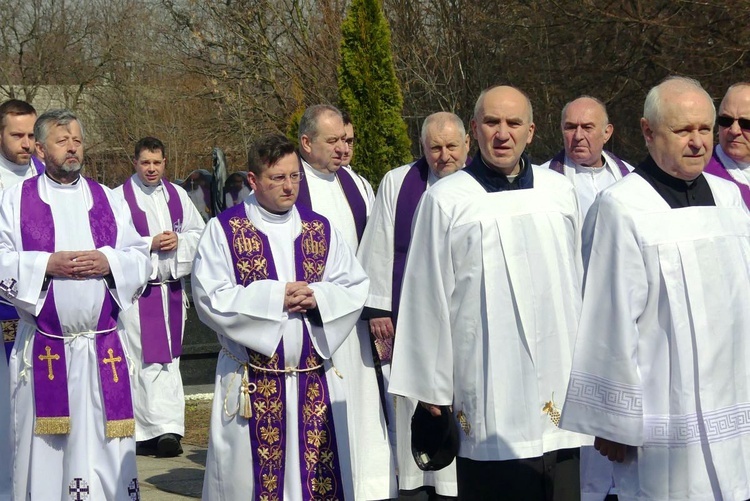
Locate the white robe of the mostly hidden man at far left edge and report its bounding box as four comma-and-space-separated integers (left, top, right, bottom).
0, 154, 37, 501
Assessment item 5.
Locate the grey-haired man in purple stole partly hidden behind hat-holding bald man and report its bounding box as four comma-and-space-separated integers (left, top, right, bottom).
357, 112, 469, 497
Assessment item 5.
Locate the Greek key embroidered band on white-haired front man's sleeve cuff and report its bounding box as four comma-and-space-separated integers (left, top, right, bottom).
566, 371, 643, 417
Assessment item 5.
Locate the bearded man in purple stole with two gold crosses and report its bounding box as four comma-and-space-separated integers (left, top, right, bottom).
0, 110, 151, 501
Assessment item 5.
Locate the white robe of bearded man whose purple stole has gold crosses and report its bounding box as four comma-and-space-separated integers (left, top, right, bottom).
0, 176, 151, 501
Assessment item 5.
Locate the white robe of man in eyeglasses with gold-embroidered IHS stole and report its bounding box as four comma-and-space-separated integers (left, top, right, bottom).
192, 195, 369, 501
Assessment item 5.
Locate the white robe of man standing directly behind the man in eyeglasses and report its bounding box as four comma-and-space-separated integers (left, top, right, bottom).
302, 161, 398, 501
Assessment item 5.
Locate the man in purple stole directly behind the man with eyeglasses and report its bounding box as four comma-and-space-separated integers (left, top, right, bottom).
297, 105, 397, 500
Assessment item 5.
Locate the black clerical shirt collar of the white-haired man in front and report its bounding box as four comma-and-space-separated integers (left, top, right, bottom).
633, 155, 716, 209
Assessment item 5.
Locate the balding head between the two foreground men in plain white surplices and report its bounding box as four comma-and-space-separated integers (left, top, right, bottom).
560, 96, 614, 167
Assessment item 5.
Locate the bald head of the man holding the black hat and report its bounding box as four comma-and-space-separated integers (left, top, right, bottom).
471, 85, 534, 175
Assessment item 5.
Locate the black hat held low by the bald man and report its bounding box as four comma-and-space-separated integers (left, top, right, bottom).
411, 404, 459, 471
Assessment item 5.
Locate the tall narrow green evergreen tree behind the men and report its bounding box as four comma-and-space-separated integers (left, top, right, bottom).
338, 0, 412, 189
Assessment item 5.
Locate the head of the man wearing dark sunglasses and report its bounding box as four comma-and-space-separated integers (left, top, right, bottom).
716, 82, 750, 164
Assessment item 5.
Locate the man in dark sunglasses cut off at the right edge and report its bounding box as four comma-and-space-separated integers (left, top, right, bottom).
704, 82, 750, 207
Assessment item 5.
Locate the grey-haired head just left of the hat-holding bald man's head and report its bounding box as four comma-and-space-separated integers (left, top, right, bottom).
422, 111, 469, 178
